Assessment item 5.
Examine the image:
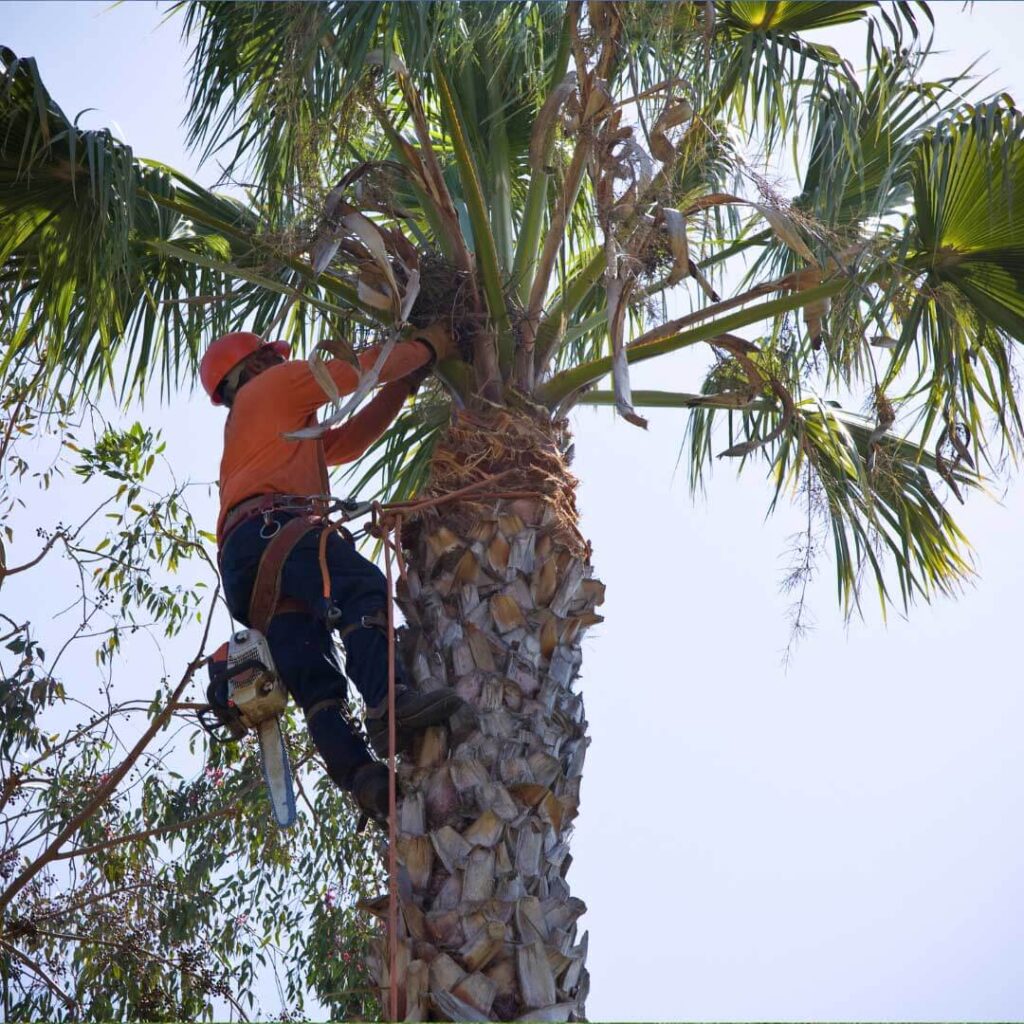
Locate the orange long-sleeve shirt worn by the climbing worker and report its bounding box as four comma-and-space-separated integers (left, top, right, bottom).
217, 341, 433, 544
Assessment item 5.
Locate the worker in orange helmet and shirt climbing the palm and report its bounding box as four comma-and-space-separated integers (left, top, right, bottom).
200, 325, 463, 821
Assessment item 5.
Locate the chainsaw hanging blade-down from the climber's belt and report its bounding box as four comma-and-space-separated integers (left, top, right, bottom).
199, 630, 296, 828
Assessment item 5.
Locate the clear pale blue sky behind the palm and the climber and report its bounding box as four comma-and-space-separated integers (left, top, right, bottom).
0, 2, 1024, 1020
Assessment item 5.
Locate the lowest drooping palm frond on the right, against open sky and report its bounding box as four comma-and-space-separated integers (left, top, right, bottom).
687, 389, 982, 612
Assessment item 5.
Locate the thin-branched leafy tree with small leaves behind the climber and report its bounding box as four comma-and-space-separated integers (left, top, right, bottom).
0, 373, 381, 1021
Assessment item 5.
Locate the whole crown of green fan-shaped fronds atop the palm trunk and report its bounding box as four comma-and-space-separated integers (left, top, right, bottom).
9, 0, 1024, 622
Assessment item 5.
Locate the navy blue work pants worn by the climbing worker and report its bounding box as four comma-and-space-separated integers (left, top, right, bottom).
220, 512, 402, 788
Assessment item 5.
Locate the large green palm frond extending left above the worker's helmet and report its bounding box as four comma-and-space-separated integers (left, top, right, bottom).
0, 49, 380, 396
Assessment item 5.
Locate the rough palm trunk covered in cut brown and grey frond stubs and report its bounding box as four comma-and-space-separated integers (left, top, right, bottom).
372, 411, 603, 1021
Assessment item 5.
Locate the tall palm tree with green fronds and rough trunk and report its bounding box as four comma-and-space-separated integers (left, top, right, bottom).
0, 0, 1024, 1020
